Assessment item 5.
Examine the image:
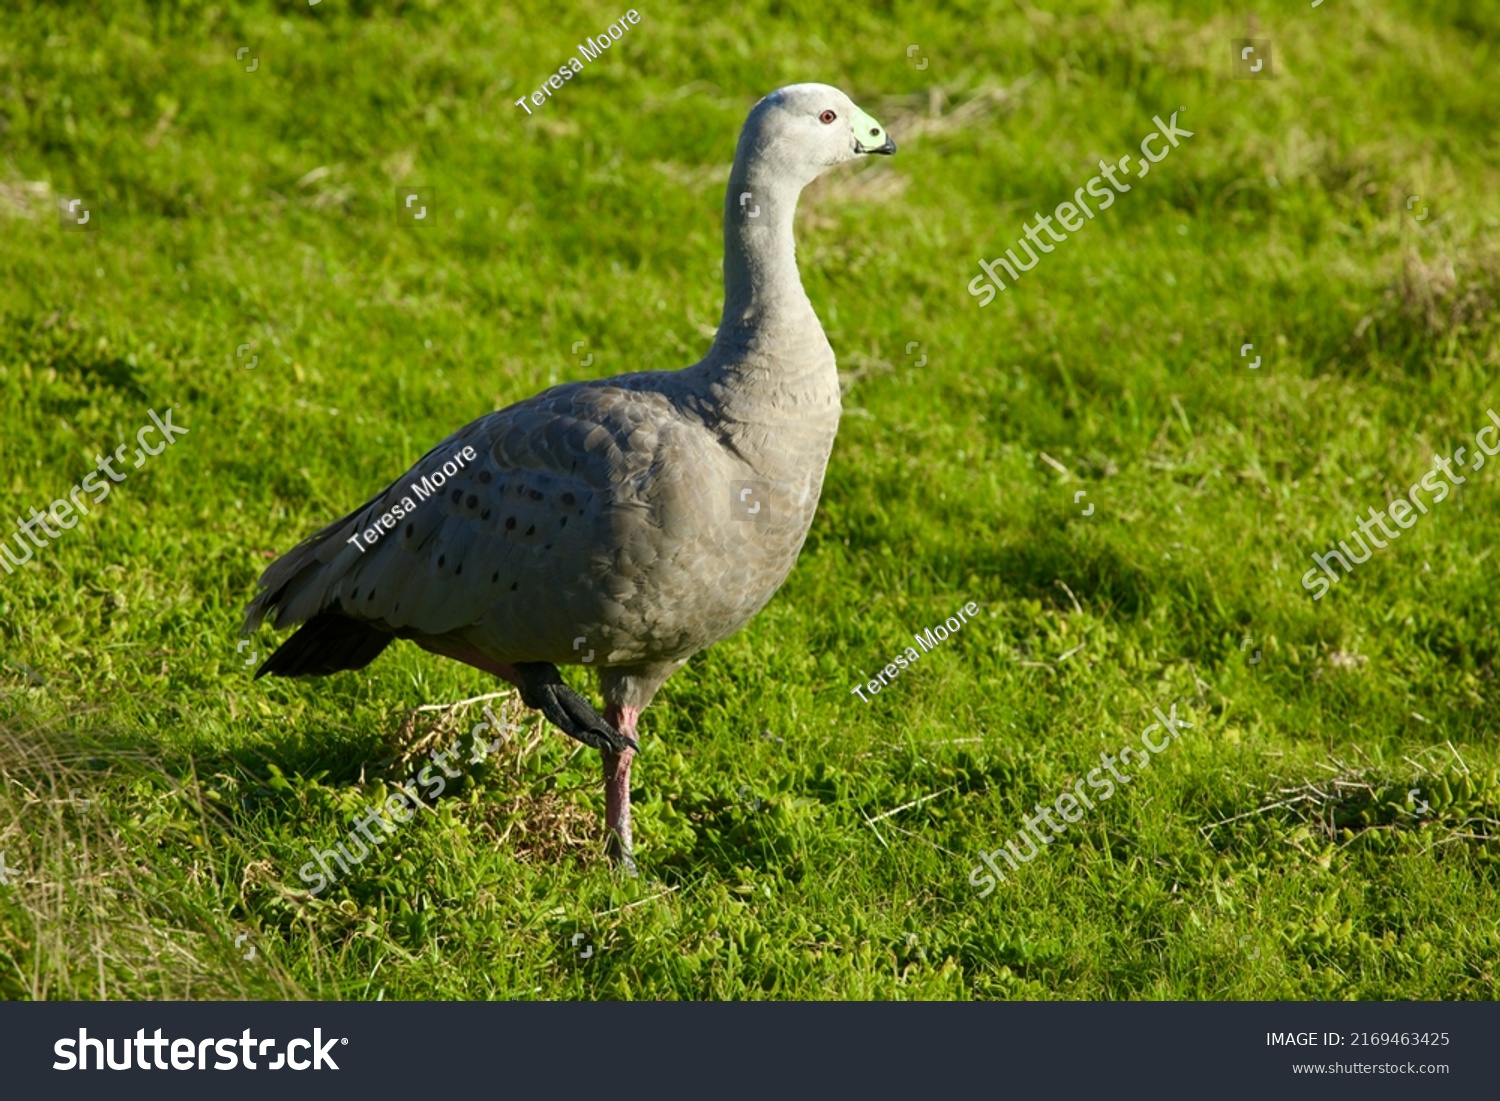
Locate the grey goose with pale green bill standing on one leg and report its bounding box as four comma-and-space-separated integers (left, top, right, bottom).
245, 84, 896, 875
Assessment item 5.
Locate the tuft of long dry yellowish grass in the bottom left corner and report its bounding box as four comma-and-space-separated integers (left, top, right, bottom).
0, 702, 305, 1001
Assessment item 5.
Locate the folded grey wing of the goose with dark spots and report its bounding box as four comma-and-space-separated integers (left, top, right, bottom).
246, 377, 687, 650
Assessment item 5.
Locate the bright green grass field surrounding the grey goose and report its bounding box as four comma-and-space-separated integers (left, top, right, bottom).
0, 0, 1500, 999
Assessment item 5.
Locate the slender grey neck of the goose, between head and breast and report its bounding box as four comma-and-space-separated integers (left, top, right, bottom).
710, 167, 827, 362
